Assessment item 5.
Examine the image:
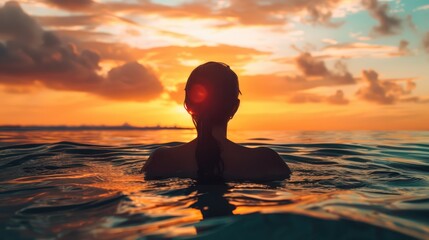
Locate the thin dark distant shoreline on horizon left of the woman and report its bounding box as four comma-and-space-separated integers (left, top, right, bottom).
0, 124, 192, 132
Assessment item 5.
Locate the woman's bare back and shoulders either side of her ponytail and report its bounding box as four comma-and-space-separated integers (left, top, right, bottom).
143, 139, 291, 181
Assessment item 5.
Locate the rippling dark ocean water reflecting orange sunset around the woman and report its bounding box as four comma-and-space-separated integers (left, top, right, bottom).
0, 130, 429, 239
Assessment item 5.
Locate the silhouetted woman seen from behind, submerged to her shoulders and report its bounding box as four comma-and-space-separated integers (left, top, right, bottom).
142, 62, 291, 183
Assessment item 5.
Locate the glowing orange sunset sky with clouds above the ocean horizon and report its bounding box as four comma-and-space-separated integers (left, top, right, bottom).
0, 0, 429, 130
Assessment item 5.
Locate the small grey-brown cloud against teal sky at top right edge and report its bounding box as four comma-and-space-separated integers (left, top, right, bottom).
362, 0, 402, 35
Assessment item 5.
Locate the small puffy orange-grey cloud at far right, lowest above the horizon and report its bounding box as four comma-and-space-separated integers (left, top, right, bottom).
356, 70, 418, 104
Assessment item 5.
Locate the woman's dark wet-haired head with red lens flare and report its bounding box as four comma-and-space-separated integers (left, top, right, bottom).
185, 62, 240, 124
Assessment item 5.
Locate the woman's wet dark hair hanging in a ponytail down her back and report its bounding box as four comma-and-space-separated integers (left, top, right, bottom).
185, 62, 240, 182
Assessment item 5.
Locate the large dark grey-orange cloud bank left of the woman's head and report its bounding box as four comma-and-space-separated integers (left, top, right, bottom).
0, 3, 163, 101
